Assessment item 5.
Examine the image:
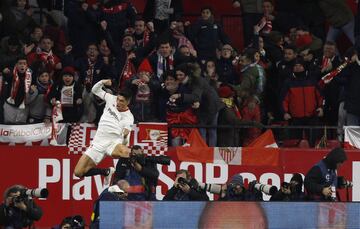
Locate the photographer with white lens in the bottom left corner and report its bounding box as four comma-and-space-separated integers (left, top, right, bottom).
0, 185, 42, 228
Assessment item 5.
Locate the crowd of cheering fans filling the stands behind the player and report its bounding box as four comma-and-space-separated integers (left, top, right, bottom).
0, 0, 360, 146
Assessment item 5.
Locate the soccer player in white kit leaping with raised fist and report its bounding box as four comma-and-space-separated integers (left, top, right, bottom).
75, 80, 134, 185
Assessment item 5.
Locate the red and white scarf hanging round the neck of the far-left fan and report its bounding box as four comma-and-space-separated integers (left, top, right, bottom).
7, 67, 32, 108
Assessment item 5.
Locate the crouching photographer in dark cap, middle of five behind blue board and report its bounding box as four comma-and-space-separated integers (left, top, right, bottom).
219, 174, 263, 201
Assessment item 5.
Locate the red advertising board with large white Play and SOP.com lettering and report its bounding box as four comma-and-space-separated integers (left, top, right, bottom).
0, 146, 360, 228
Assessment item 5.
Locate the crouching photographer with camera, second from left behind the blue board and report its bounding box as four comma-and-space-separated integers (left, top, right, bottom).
163, 169, 209, 201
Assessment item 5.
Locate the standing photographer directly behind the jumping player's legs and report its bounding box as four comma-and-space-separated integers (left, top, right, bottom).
114, 145, 159, 200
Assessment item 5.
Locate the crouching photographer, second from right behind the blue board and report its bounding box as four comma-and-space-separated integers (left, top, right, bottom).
270, 173, 305, 201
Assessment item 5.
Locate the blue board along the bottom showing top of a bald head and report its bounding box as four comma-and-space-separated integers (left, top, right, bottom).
100, 201, 360, 229
